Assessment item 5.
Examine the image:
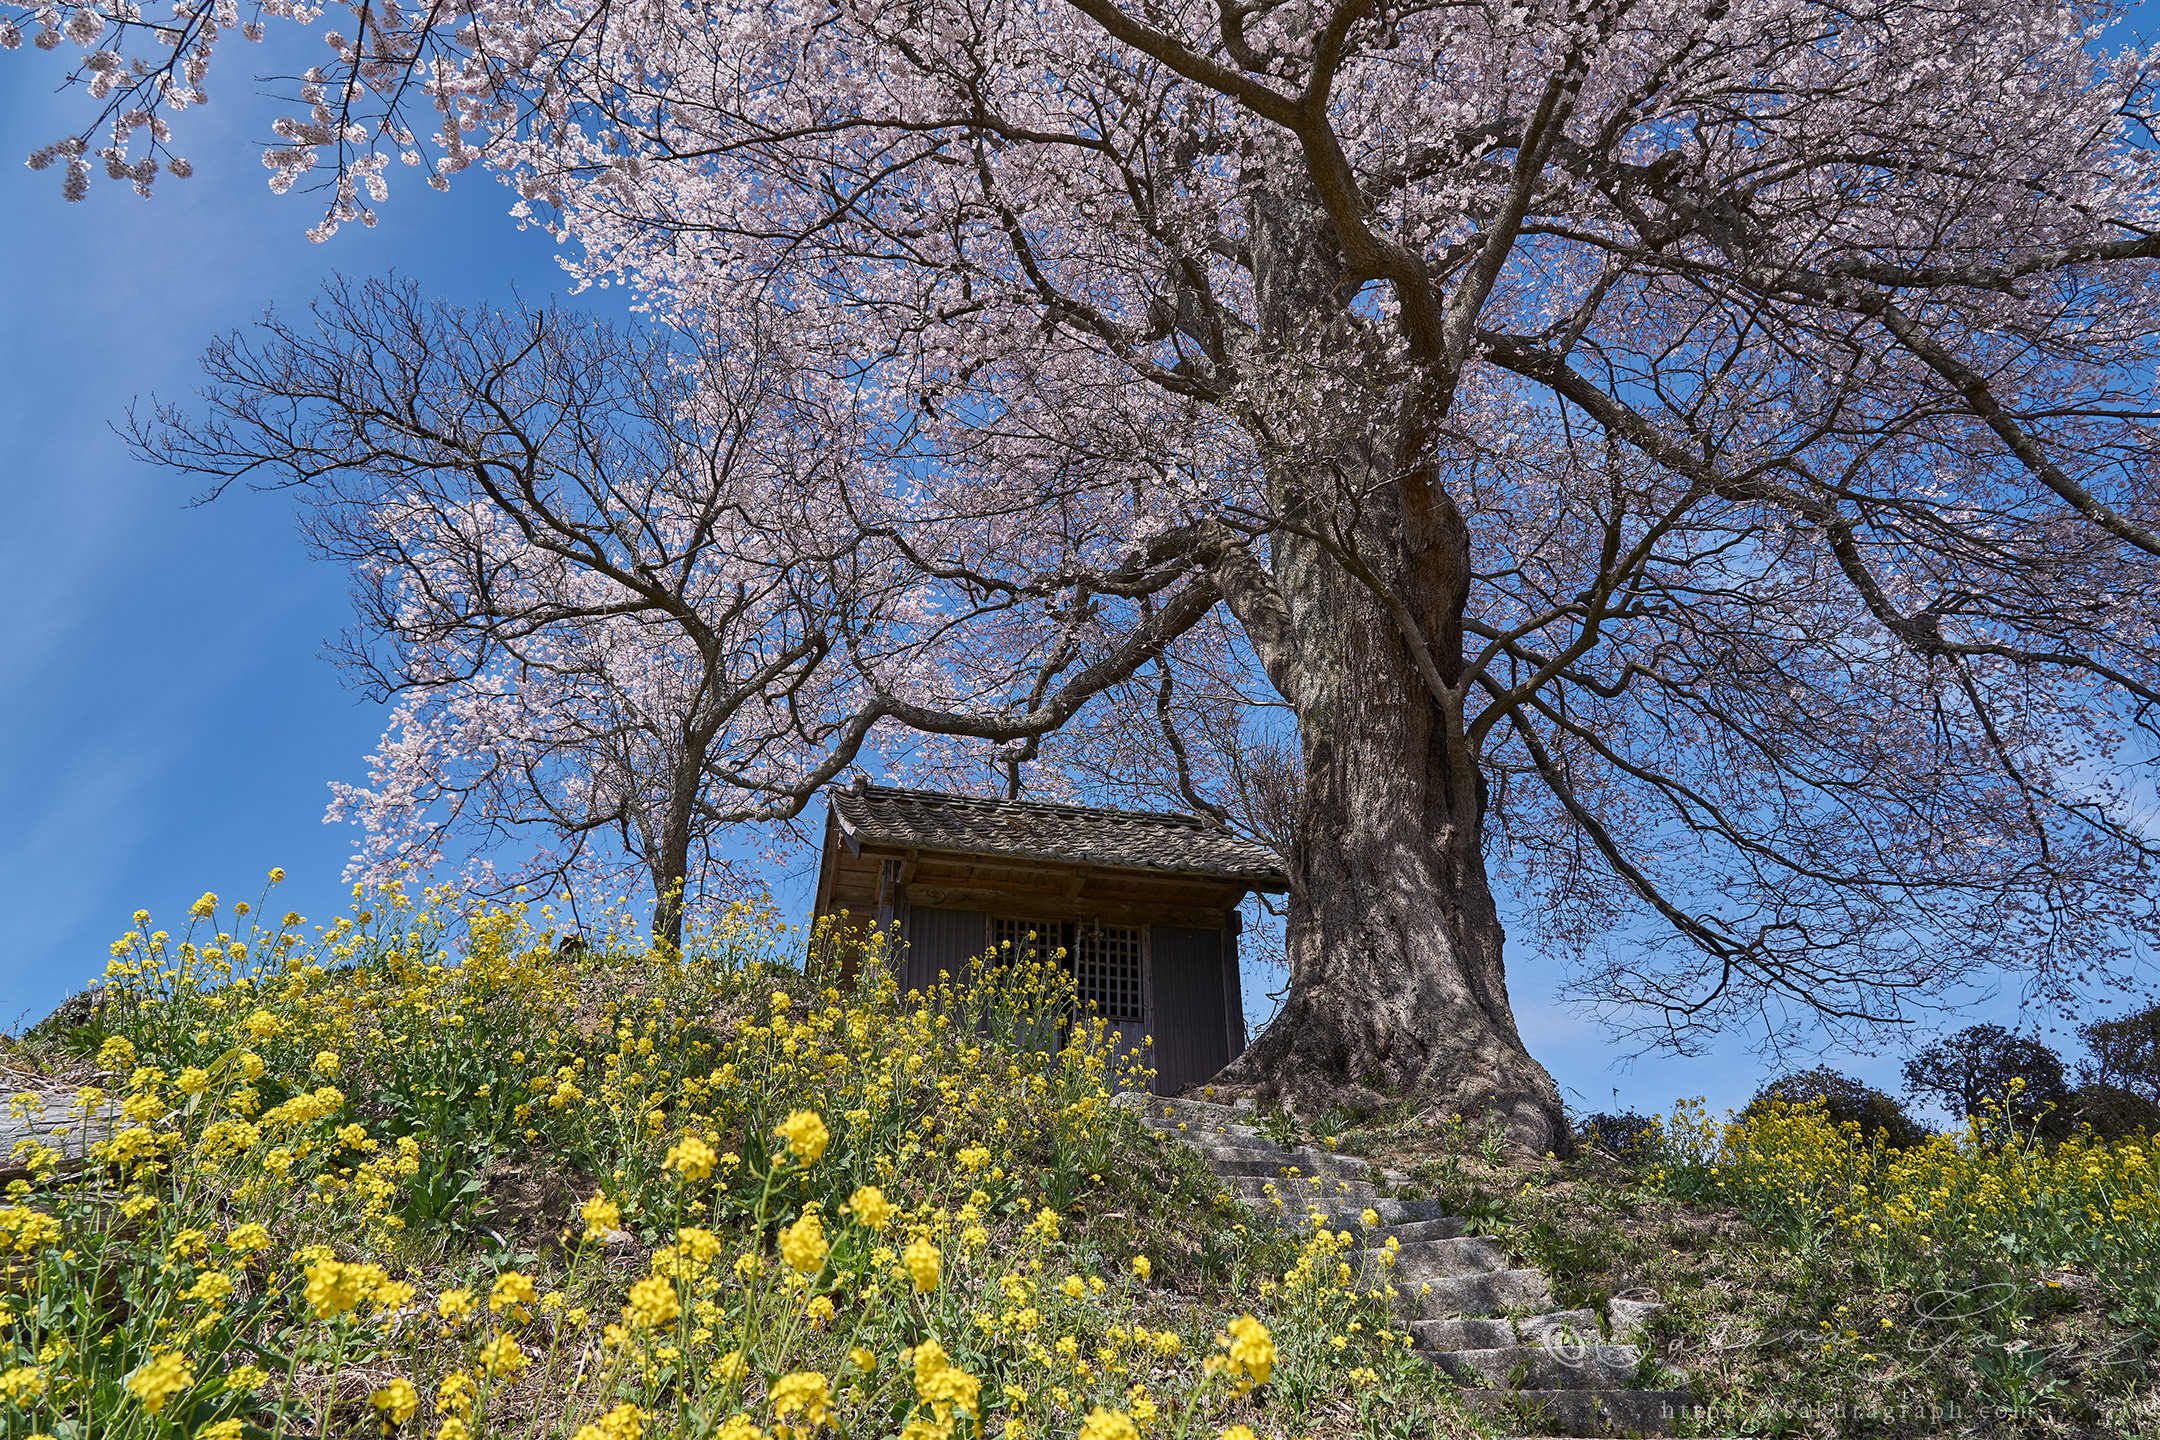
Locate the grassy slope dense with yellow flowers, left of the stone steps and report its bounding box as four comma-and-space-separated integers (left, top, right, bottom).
0, 889, 1462, 1440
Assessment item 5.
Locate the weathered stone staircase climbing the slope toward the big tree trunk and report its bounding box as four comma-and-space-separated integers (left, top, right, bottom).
1119, 1095, 1698, 1436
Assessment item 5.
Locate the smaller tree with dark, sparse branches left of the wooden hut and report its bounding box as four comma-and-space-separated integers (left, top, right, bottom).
134, 281, 892, 943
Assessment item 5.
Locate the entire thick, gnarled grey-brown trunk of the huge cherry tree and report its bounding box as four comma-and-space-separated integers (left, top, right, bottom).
1220, 147, 1568, 1153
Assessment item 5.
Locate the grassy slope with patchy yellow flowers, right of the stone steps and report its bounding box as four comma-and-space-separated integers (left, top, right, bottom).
1296, 1075, 2160, 1440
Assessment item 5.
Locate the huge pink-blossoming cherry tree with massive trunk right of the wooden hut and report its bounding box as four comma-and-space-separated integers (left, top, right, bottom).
39, 0, 2160, 1146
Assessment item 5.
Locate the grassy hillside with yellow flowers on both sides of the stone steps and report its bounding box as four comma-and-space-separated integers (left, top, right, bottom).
0, 872, 2160, 1440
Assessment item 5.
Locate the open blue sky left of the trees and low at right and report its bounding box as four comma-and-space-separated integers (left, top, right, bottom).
0, 28, 2108, 1110
